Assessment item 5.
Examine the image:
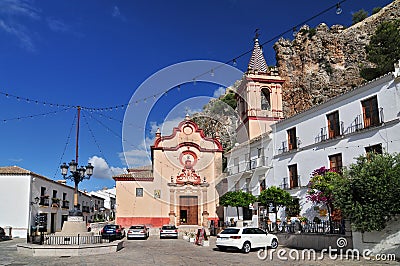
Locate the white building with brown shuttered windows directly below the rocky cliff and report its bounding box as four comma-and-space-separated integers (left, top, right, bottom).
266, 69, 400, 219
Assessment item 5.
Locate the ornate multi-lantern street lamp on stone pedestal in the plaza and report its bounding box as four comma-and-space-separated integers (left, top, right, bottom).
60, 160, 94, 216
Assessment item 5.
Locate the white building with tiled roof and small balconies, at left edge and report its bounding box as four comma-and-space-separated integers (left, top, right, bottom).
0, 166, 104, 238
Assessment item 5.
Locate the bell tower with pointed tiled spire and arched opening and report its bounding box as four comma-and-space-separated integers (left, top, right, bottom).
236, 31, 284, 143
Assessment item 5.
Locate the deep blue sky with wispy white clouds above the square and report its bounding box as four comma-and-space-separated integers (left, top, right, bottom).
0, 0, 391, 190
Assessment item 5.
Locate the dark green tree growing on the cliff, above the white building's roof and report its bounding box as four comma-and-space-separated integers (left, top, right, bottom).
360, 20, 400, 80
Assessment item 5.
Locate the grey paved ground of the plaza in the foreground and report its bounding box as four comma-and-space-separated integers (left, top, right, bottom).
0, 236, 400, 266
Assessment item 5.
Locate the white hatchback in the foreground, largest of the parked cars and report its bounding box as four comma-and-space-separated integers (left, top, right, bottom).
216, 227, 278, 253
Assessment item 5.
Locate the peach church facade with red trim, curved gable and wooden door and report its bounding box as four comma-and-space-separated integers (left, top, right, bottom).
113, 116, 223, 227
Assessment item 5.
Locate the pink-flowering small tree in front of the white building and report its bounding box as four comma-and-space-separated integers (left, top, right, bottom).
307, 167, 340, 229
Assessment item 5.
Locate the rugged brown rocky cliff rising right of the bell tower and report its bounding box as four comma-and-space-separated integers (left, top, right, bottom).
274, 0, 400, 117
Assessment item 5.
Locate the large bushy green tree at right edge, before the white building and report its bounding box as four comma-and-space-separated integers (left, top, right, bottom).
333, 153, 400, 232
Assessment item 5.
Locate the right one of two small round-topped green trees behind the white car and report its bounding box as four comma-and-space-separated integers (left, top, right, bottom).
257, 186, 293, 219
